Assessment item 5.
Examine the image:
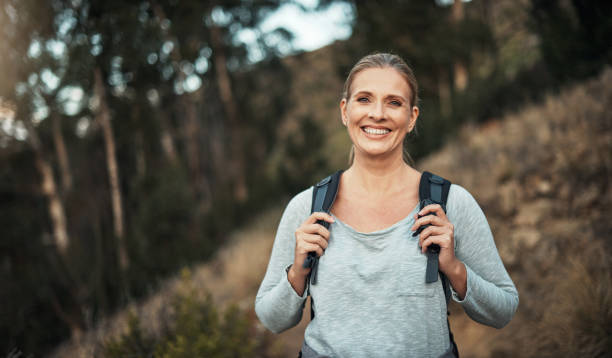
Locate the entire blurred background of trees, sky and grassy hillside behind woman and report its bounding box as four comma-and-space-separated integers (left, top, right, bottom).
0, 0, 612, 358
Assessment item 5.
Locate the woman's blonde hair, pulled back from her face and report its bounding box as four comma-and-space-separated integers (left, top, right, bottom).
342, 52, 419, 166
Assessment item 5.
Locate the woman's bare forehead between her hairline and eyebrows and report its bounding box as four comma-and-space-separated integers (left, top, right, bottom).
351, 67, 410, 98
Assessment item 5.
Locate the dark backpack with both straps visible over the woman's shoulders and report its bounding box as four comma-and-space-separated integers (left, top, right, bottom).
302, 170, 459, 358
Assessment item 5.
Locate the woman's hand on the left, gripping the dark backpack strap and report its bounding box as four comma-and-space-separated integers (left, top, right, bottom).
291, 212, 334, 277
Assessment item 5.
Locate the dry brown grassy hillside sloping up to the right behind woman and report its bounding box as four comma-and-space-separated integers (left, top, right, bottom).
52, 69, 612, 357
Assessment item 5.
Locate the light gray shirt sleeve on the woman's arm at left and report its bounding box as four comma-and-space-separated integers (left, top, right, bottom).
255, 187, 312, 333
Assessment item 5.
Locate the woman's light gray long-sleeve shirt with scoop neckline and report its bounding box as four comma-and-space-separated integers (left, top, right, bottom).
255, 184, 518, 357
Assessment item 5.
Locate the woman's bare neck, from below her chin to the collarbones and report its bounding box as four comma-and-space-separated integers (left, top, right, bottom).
342, 153, 420, 197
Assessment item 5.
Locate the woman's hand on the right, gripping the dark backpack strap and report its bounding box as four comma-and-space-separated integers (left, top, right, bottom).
411, 204, 460, 275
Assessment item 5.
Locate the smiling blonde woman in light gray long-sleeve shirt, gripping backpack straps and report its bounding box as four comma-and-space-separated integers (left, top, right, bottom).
255, 54, 518, 357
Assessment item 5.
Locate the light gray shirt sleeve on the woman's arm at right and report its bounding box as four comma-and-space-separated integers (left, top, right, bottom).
447, 184, 519, 328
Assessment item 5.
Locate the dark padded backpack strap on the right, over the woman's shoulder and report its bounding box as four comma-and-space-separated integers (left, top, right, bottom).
415, 171, 451, 283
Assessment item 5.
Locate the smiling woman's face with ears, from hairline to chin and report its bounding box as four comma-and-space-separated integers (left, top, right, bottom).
340, 68, 419, 158
